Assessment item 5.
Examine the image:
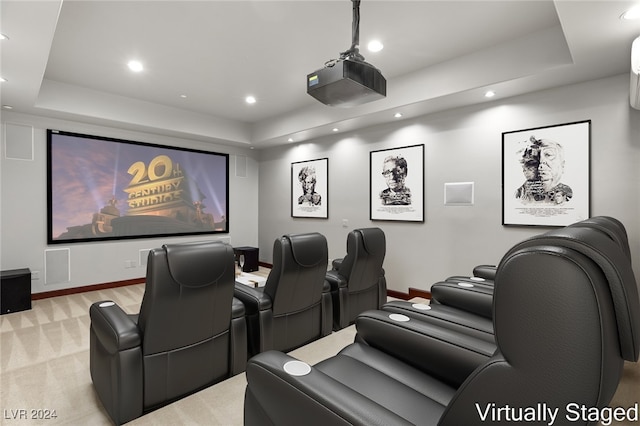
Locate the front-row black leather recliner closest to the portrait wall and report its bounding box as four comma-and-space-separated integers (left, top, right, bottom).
326, 228, 387, 330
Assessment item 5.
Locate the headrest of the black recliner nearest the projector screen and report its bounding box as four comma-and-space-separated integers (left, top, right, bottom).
162, 241, 233, 287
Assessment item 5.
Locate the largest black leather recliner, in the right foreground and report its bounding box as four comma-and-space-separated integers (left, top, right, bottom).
245, 231, 640, 426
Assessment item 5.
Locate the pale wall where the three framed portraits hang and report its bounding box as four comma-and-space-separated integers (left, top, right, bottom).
259, 75, 640, 292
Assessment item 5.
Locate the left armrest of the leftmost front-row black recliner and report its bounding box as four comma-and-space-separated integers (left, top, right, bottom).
89, 301, 142, 354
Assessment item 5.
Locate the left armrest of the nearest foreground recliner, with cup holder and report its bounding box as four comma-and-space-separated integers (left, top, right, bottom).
244, 351, 411, 426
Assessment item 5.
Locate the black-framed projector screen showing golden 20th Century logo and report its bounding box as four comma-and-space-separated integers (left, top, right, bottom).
47, 129, 229, 244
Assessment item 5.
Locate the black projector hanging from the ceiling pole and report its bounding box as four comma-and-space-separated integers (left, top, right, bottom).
307, 58, 387, 107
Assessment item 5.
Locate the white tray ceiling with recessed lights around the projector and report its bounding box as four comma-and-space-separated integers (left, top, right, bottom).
0, 0, 640, 148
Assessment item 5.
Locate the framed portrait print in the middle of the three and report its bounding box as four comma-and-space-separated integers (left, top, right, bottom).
369, 145, 424, 222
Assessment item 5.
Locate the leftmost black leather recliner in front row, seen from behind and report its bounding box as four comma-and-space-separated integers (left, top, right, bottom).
89, 242, 247, 424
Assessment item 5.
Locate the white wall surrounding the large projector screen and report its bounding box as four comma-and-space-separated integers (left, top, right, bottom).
0, 112, 259, 293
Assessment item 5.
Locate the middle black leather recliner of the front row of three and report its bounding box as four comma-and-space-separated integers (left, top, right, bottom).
235, 232, 333, 354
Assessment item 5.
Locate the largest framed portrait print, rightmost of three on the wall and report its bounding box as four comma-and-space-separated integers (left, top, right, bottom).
502, 120, 591, 226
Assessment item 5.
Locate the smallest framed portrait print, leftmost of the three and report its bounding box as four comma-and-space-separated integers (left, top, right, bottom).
291, 158, 329, 219
